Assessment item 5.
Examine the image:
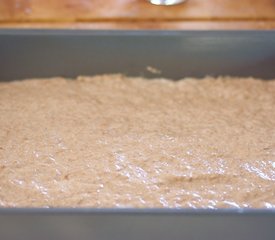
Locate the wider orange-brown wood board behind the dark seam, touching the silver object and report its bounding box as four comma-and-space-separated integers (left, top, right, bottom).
0, 0, 275, 22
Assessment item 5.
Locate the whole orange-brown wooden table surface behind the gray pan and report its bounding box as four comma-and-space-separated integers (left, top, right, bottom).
0, 0, 275, 29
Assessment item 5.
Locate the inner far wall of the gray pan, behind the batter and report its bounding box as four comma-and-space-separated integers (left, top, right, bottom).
0, 30, 275, 81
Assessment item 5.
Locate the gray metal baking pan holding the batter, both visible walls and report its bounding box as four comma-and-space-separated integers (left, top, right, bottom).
0, 30, 275, 240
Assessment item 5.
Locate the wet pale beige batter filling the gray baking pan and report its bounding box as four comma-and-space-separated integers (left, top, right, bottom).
0, 75, 275, 208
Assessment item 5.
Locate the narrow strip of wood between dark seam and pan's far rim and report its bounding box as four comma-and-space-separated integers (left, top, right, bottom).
0, 21, 275, 30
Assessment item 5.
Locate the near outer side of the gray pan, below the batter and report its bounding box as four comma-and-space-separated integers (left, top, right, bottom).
0, 209, 275, 240
